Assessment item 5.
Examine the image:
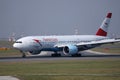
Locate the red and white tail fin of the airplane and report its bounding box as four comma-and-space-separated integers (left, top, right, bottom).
96, 13, 112, 36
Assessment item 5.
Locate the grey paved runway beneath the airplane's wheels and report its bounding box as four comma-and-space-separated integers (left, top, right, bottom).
0, 51, 120, 62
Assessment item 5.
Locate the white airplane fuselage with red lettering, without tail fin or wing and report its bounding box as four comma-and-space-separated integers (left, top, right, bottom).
13, 35, 107, 51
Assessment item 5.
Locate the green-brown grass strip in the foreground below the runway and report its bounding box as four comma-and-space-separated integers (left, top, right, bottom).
0, 59, 120, 80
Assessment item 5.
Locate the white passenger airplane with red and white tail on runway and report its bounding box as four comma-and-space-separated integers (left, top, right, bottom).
13, 13, 120, 57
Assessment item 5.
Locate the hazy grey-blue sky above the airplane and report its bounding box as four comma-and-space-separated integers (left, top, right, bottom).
0, 0, 120, 38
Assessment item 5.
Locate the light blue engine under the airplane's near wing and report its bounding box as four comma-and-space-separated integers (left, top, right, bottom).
63, 45, 78, 55
